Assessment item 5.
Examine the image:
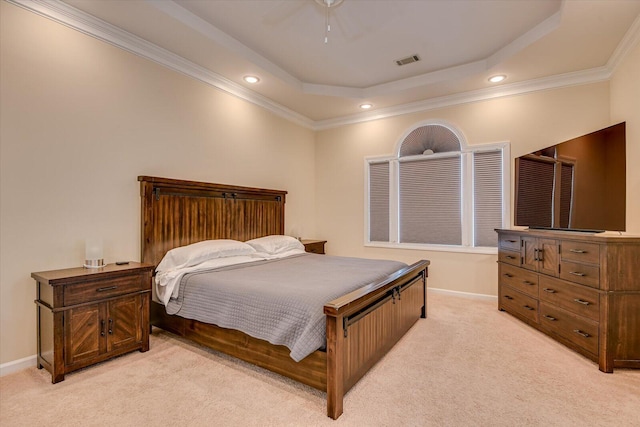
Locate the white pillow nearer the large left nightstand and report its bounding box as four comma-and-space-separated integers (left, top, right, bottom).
156, 239, 256, 271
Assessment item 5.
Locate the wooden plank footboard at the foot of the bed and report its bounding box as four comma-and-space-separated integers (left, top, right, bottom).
324, 260, 429, 419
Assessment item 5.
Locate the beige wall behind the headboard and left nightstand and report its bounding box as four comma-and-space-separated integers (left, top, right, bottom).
0, 2, 315, 363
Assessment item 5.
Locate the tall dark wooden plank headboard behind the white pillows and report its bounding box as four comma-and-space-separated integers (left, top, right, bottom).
138, 176, 287, 265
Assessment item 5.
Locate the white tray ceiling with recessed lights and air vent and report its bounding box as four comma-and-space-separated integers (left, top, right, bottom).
20, 0, 640, 128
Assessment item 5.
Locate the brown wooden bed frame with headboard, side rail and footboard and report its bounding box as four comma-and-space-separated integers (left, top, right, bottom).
138, 176, 429, 419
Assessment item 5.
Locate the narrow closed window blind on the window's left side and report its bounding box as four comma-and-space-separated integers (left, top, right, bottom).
369, 162, 389, 242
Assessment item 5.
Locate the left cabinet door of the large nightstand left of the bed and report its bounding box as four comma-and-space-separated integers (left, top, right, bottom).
64, 304, 106, 366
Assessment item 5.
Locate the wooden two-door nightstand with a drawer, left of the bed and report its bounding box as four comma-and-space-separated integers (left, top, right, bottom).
31, 262, 153, 384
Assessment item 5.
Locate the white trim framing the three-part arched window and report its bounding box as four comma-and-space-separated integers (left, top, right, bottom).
364, 135, 511, 254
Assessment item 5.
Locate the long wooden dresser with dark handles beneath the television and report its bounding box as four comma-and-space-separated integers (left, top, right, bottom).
496, 230, 640, 372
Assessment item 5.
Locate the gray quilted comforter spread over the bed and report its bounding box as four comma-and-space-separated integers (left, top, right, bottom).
167, 254, 406, 362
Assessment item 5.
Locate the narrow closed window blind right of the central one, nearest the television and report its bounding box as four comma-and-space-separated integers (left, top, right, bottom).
473, 151, 502, 247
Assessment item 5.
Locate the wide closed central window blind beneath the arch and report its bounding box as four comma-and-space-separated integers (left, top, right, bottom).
399, 154, 462, 245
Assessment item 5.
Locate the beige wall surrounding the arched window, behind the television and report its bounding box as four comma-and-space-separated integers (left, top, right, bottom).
316, 77, 640, 295
